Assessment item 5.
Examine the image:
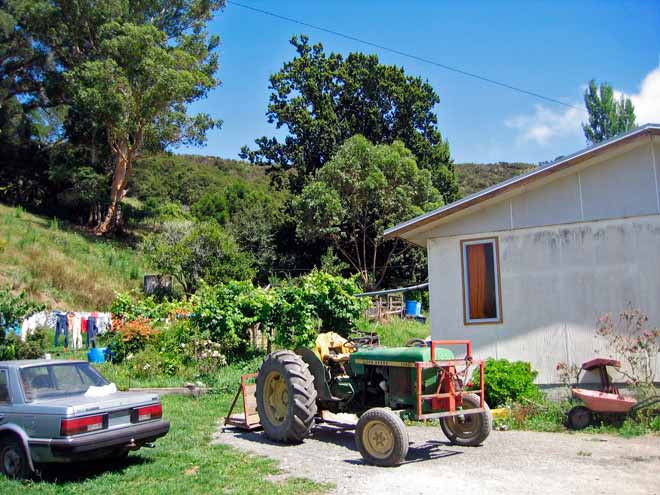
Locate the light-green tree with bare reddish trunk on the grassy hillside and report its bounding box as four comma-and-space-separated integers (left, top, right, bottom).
67, 23, 217, 234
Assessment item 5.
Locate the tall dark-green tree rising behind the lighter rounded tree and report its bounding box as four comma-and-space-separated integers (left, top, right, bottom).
241, 35, 458, 201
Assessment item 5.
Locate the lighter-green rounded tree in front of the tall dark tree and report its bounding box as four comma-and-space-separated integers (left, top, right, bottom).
294, 136, 442, 289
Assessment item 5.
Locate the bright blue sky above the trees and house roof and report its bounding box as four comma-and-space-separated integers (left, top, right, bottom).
177, 0, 660, 166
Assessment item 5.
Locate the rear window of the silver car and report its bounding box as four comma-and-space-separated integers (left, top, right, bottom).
21, 363, 108, 400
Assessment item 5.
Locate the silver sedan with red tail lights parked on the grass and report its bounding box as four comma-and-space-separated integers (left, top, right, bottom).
0, 360, 170, 478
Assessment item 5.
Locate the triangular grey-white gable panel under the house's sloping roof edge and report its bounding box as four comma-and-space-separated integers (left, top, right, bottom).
420, 139, 660, 245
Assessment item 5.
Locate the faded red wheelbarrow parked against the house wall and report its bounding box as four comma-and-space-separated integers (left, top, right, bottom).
567, 358, 660, 430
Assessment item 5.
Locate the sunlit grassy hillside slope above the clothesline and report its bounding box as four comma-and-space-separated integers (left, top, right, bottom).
0, 205, 147, 310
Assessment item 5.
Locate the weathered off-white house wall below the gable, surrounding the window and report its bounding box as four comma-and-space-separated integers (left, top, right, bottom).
427, 216, 660, 383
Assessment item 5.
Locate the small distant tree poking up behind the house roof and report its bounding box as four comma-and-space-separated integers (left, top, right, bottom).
582, 79, 636, 144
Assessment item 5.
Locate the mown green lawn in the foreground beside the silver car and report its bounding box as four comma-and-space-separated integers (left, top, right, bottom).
0, 394, 330, 495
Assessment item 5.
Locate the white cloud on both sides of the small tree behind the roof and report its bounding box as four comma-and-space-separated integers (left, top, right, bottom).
504, 58, 660, 146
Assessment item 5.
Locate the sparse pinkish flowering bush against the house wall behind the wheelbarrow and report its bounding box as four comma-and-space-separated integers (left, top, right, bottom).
596, 309, 660, 390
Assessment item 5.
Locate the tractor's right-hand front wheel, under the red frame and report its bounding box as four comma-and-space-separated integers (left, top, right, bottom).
440, 394, 493, 447
